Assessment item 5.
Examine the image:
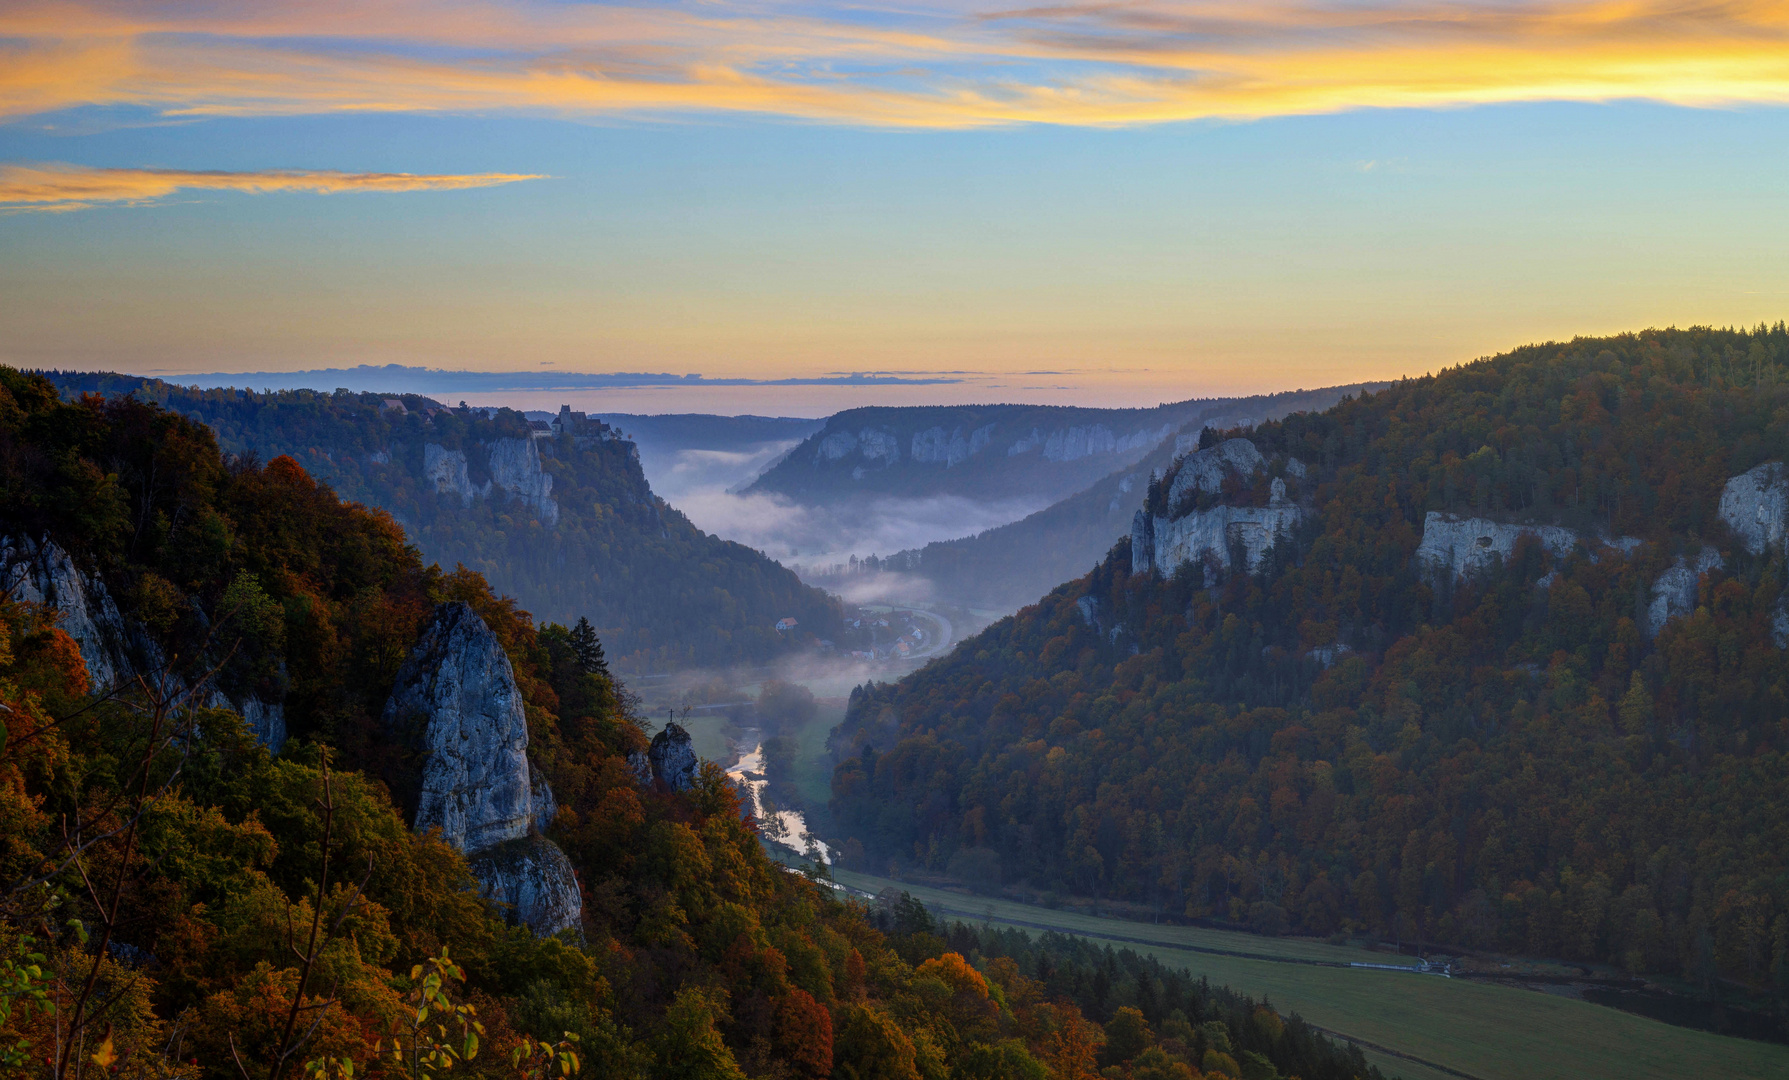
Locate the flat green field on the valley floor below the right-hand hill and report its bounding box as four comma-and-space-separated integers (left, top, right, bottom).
835, 871, 1789, 1080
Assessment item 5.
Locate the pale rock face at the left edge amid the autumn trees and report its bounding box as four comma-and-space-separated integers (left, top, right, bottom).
0, 536, 134, 692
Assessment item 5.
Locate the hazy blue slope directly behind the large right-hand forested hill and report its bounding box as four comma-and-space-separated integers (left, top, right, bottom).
812, 383, 1383, 612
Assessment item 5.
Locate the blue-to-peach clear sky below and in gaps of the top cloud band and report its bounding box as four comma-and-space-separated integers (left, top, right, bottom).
0, 5, 1789, 413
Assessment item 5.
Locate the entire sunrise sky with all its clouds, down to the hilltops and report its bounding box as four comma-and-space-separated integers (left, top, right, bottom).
0, 0, 1789, 415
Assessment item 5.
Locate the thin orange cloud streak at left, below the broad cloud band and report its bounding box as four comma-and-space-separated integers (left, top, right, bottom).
0, 165, 544, 213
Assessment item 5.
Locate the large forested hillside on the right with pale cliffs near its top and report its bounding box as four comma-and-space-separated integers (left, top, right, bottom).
832, 324, 1789, 994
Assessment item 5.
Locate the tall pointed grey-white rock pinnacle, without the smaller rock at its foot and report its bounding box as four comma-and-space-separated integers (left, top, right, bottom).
385, 604, 533, 853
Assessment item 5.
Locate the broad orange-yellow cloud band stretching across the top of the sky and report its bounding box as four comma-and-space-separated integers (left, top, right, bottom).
0, 0, 1789, 127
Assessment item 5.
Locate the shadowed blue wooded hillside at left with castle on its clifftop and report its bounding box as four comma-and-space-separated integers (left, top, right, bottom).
50, 372, 841, 671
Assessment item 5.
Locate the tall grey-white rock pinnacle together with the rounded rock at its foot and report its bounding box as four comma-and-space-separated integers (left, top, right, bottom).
385, 603, 581, 933
